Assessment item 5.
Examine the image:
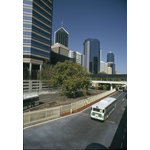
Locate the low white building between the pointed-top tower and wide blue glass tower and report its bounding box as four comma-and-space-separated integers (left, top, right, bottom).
68, 50, 82, 64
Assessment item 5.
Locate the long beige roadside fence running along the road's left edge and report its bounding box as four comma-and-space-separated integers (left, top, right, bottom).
23, 89, 116, 125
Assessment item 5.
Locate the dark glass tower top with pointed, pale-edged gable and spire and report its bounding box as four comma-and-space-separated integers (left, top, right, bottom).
54, 23, 69, 47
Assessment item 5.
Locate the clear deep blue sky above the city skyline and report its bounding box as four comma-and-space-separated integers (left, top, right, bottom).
52, 0, 127, 74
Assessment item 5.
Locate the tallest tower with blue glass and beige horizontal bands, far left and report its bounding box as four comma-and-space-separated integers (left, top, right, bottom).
23, 0, 53, 79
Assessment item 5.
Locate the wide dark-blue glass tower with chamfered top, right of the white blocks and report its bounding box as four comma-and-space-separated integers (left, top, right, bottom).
82, 39, 100, 74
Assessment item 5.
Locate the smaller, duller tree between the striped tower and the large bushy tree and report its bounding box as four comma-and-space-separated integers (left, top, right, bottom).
38, 61, 56, 89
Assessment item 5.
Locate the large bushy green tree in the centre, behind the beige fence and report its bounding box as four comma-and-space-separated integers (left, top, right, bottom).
52, 60, 91, 97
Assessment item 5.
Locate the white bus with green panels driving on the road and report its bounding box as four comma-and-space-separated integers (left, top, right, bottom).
91, 97, 116, 121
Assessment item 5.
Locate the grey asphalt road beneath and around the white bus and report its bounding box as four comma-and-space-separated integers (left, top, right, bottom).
23, 92, 127, 149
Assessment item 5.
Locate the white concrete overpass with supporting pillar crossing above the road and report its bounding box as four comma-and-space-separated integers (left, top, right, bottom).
92, 80, 127, 90
